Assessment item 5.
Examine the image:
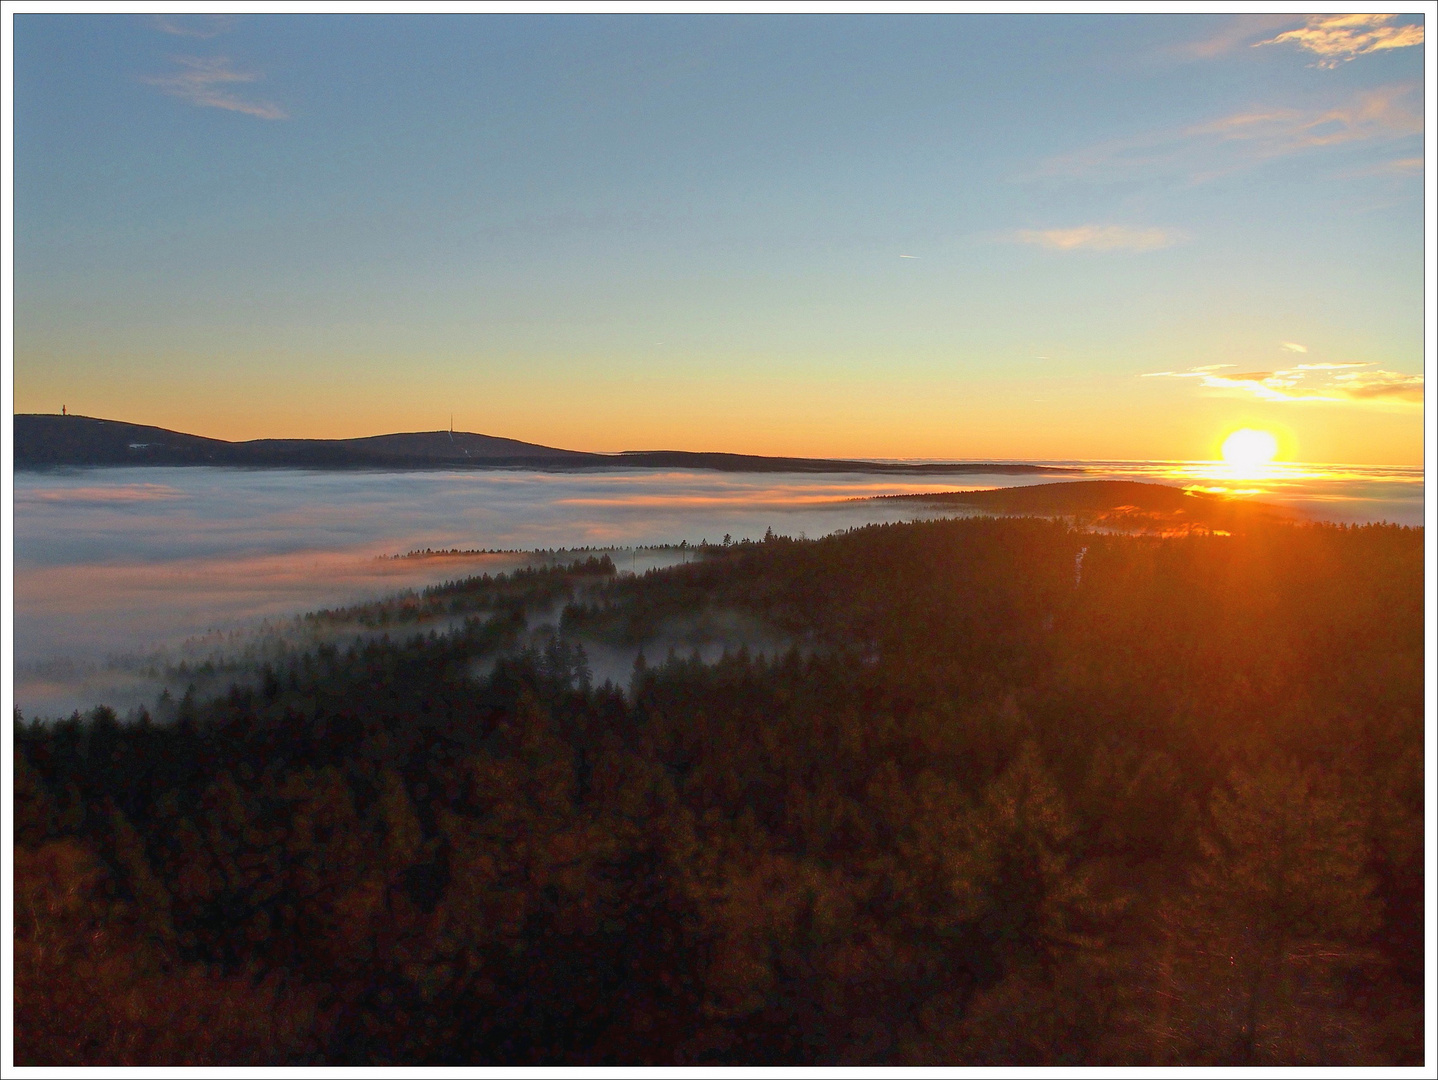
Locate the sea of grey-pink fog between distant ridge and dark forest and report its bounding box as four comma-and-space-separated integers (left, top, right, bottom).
13, 462, 1424, 716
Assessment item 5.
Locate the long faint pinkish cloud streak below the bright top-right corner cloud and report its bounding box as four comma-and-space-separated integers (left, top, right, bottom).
1037, 83, 1424, 181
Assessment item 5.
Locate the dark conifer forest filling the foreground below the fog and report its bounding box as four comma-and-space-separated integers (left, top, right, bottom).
14, 519, 1424, 1064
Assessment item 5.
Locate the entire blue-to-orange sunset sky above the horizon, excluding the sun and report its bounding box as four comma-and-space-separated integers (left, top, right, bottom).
9, 14, 1424, 465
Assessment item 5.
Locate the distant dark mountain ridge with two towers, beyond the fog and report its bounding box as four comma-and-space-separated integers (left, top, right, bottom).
14, 413, 1081, 475
